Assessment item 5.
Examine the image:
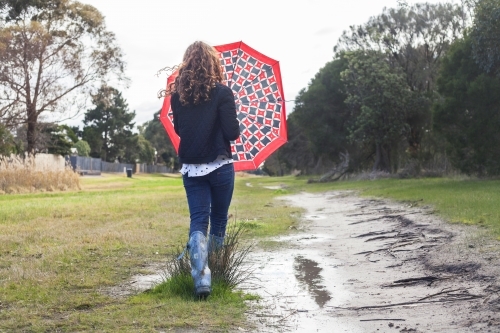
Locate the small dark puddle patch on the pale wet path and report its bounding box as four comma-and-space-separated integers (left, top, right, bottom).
294, 256, 332, 307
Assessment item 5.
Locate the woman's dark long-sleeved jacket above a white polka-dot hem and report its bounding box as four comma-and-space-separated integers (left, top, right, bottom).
170, 83, 240, 164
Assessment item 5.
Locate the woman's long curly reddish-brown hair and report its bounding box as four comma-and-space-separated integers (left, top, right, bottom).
163, 41, 224, 105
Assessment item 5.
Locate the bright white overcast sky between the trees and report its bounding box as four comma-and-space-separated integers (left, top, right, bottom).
77, 0, 456, 124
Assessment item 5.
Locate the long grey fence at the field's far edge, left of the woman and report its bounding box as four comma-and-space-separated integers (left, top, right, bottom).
66, 156, 172, 175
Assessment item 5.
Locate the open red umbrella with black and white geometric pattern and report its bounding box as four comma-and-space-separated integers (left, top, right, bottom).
160, 42, 287, 171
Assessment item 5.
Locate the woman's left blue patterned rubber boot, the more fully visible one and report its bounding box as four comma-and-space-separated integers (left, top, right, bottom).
188, 231, 212, 298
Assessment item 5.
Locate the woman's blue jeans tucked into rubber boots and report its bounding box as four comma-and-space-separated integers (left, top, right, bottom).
182, 163, 234, 237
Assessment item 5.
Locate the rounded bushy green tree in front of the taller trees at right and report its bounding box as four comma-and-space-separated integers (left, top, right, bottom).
342, 51, 412, 172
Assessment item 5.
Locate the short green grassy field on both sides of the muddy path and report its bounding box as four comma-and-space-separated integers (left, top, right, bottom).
0, 175, 500, 332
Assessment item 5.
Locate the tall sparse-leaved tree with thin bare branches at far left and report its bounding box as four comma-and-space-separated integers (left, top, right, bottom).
0, 0, 124, 153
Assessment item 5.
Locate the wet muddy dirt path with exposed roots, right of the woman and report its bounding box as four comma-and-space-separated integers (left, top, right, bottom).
239, 192, 500, 333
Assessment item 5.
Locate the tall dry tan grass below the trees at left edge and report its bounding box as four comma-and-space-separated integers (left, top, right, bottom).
0, 156, 80, 194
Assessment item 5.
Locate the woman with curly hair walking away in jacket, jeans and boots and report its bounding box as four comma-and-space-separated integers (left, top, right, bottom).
167, 42, 240, 297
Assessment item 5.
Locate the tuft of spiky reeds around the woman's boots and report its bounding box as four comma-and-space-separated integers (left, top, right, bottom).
164, 222, 255, 290
